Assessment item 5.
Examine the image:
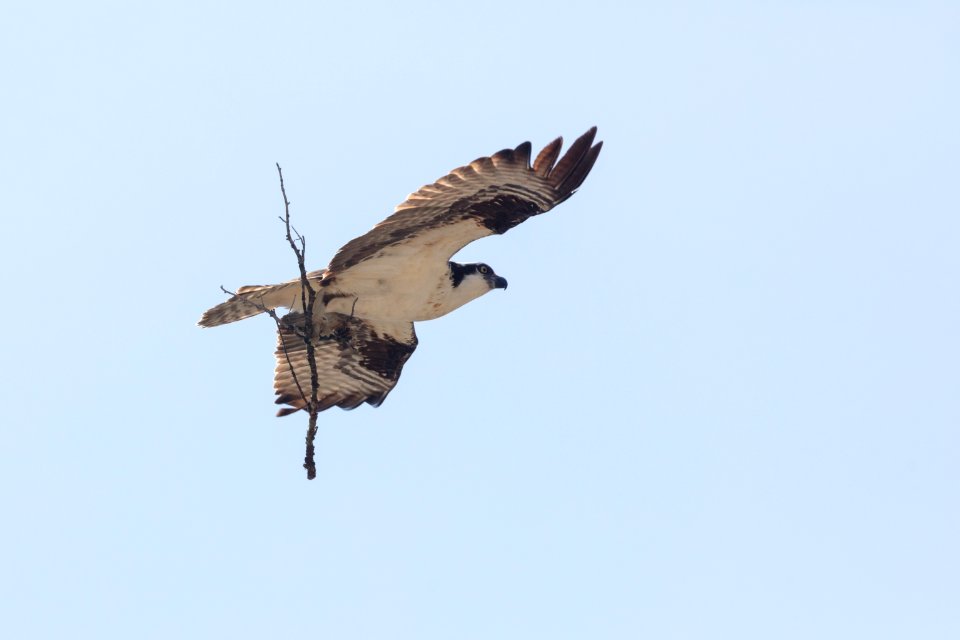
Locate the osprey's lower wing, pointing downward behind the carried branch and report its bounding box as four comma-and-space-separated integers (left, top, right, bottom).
273, 313, 417, 416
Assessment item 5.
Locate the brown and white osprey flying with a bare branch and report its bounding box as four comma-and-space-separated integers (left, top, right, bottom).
199, 127, 603, 416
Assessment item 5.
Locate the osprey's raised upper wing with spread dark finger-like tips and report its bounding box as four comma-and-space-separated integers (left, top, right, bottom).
326, 127, 603, 276
